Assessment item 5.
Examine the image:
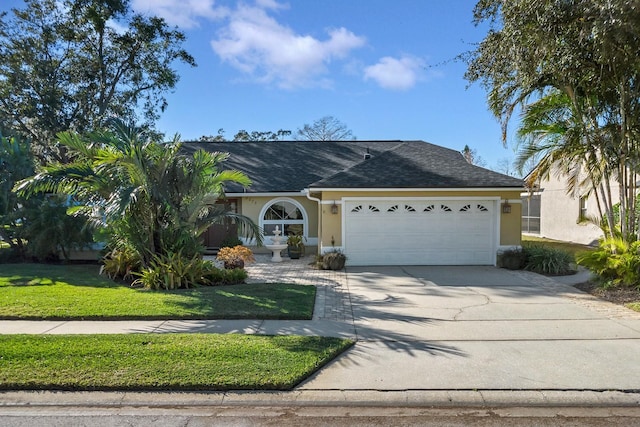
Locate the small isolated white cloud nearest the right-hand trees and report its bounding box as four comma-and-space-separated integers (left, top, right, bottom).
364, 55, 424, 90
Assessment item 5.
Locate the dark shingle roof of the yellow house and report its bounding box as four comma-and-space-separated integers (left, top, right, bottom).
183, 141, 523, 193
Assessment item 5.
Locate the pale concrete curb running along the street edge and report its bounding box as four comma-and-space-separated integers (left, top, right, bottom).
0, 390, 640, 411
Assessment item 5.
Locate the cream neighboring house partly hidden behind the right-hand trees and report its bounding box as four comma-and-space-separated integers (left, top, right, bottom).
522, 173, 617, 245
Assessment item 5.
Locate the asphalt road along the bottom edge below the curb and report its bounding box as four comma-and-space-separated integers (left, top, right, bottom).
0, 406, 640, 427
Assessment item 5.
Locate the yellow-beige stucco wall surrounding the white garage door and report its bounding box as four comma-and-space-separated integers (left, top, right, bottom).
319, 191, 522, 248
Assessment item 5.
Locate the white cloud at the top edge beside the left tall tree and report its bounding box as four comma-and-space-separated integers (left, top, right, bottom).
131, 0, 227, 29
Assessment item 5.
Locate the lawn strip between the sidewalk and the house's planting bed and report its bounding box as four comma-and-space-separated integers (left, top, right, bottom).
0, 264, 316, 320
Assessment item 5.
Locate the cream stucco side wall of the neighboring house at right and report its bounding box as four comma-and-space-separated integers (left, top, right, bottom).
540, 174, 618, 244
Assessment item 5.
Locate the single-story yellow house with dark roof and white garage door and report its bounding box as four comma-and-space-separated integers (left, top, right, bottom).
184, 141, 523, 265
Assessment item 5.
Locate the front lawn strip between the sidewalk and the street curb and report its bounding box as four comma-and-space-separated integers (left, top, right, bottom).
0, 334, 353, 390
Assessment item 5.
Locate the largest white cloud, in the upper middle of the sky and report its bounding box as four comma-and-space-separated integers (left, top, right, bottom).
211, 0, 365, 89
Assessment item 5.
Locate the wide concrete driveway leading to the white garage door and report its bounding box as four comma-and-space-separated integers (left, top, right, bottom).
299, 267, 640, 391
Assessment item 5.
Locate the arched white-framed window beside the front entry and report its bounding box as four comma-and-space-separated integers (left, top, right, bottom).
260, 199, 307, 237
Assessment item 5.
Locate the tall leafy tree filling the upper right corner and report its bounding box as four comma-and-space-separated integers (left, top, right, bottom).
466, 0, 640, 240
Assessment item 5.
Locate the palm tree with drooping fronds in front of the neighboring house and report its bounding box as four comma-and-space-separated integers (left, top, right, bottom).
516, 90, 619, 237
